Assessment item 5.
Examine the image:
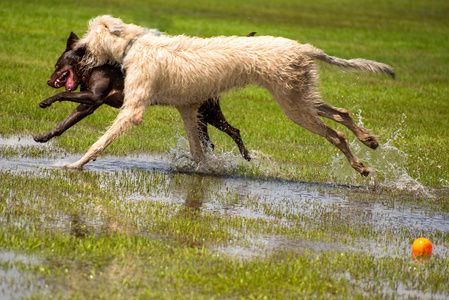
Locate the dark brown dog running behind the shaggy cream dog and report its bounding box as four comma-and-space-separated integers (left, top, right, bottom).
33, 32, 251, 161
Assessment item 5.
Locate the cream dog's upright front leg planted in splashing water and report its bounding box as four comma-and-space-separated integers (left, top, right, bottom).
176, 104, 204, 163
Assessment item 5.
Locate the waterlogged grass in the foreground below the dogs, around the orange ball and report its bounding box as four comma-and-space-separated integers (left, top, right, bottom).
0, 157, 449, 298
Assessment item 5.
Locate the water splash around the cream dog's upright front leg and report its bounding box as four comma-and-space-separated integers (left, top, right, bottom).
169, 136, 241, 175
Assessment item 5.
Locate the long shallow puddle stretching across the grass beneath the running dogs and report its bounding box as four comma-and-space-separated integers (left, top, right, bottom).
0, 137, 449, 258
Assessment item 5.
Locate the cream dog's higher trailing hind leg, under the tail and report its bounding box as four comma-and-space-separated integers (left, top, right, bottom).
315, 102, 379, 149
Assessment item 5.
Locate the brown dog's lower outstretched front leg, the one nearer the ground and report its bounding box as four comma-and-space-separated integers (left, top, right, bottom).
33, 104, 101, 143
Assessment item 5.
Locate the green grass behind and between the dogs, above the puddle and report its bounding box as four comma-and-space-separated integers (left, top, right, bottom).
0, 1, 449, 187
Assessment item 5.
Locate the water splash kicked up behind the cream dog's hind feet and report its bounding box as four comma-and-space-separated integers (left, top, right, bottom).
330, 110, 431, 196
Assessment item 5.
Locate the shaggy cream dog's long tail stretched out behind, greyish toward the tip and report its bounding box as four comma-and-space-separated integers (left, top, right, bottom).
303, 44, 395, 79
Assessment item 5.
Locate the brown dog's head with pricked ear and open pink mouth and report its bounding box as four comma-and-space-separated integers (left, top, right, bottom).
47, 32, 85, 92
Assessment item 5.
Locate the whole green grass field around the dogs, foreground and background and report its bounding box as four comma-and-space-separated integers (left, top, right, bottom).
0, 0, 449, 299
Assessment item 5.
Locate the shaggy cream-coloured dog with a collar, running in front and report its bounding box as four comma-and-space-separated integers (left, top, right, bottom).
68, 16, 394, 176
